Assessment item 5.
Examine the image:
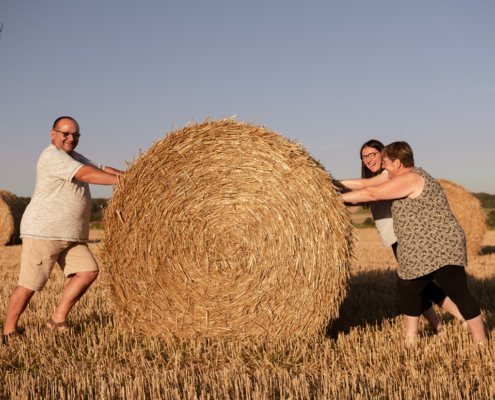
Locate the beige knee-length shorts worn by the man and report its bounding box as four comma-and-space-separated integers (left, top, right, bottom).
18, 238, 98, 292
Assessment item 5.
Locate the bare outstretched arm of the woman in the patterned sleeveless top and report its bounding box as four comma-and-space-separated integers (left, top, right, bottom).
340, 172, 425, 204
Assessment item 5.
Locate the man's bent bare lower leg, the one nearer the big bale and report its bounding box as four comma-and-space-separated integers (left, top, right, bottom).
47, 271, 98, 328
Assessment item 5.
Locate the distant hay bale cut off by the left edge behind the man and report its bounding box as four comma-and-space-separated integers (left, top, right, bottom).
0, 190, 26, 246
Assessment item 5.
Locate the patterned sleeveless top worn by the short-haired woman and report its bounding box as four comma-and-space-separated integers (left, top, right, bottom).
392, 168, 467, 280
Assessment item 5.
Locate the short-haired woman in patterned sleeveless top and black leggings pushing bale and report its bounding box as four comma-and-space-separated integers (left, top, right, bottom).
340, 142, 485, 344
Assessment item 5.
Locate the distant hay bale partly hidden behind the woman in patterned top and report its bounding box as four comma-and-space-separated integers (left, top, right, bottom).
437, 179, 486, 259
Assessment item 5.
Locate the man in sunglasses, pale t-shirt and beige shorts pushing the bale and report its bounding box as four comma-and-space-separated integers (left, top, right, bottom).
2, 117, 122, 342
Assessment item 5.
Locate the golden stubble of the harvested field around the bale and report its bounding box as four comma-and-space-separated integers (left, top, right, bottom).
0, 229, 495, 399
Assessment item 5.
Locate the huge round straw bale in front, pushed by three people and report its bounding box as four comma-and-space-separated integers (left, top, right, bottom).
100, 118, 353, 338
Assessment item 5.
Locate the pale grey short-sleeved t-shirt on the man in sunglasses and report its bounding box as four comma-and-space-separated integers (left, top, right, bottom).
21, 144, 105, 242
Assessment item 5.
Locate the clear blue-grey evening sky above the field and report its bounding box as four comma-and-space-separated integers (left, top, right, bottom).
0, 0, 495, 197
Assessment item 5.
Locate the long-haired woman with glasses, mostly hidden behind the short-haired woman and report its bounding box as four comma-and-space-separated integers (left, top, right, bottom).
334, 139, 467, 335
